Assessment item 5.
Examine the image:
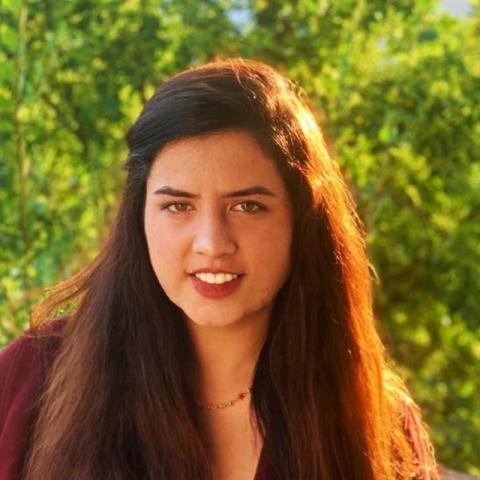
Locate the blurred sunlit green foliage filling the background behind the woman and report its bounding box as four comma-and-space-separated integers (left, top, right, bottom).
0, 0, 480, 474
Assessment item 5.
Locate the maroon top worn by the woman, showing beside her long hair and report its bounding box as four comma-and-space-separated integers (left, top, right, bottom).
0, 320, 433, 480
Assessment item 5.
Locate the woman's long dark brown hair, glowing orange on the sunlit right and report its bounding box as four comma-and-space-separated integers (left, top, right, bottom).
26, 59, 433, 480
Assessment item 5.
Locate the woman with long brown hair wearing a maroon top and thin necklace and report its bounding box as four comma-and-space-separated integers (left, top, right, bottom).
0, 59, 437, 480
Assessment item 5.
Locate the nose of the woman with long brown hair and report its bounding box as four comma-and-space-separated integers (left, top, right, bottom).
193, 213, 237, 258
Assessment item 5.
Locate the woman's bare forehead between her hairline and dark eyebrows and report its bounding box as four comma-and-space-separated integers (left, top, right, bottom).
149, 131, 282, 188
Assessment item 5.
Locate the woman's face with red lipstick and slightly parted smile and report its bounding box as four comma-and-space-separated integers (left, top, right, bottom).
145, 131, 293, 326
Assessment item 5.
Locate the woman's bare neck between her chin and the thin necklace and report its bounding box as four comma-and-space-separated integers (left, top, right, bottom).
187, 315, 268, 404
